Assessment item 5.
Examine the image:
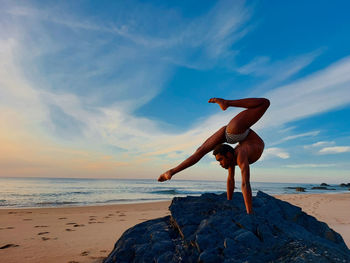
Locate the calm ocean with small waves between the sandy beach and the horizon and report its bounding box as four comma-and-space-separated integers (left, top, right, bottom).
0, 178, 349, 208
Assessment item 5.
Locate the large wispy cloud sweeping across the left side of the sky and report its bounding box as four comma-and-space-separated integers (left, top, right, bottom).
0, 2, 256, 176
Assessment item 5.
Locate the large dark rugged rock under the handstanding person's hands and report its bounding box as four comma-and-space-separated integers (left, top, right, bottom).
104, 192, 350, 263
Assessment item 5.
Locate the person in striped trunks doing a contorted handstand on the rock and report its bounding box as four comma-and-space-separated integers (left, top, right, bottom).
158, 98, 270, 213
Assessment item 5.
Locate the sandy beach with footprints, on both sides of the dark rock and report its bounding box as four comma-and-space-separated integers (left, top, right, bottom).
0, 193, 350, 263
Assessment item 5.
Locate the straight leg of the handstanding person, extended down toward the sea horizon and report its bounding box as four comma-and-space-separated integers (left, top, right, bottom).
158, 126, 226, 182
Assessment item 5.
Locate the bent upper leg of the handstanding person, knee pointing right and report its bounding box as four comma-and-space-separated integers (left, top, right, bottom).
209, 98, 270, 134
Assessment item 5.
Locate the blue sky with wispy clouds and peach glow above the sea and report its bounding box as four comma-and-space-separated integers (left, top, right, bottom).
0, 1, 350, 183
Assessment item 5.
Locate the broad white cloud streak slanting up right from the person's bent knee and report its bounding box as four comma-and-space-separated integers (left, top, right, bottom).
249, 57, 350, 132
